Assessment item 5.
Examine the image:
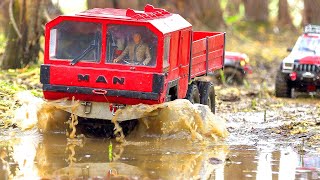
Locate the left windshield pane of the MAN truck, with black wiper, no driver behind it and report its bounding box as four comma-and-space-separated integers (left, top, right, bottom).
49, 21, 101, 62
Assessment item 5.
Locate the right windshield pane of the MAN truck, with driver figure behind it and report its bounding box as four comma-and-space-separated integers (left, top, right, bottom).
106, 24, 158, 66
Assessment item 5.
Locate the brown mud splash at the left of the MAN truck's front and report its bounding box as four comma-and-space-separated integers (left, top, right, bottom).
11, 91, 79, 138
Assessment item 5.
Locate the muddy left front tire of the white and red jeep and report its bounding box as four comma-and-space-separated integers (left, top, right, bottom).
275, 70, 291, 97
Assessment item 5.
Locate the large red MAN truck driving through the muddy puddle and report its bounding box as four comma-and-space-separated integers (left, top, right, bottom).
40, 5, 225, 136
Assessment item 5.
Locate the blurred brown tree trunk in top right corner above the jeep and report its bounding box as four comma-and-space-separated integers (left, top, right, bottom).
303, 0, 320, 25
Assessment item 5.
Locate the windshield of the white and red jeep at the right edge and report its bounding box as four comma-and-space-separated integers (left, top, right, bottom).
293, 37, 320, 54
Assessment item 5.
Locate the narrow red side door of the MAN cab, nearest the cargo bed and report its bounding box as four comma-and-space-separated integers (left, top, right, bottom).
178, 29, 191, 98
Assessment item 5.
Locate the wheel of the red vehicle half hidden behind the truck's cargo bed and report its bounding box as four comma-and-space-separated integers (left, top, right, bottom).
223, 67, 244, 85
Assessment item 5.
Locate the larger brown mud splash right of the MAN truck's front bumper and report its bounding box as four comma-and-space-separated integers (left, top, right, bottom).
112, 99, 228, 142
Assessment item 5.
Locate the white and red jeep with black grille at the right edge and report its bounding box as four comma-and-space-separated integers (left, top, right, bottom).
275, 25, 320, 98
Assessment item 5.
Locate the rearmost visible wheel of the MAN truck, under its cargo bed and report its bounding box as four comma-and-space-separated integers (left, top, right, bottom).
199, 82, 216, 113
